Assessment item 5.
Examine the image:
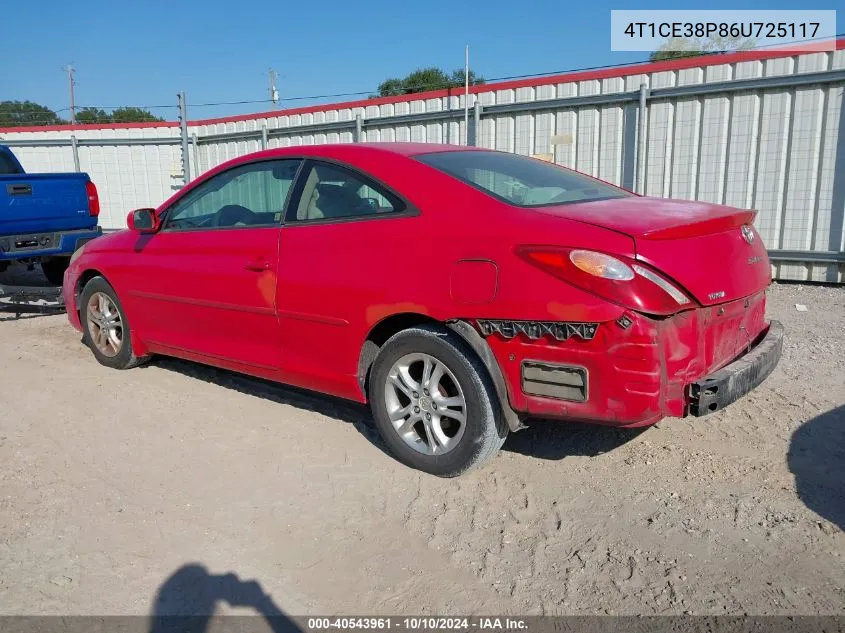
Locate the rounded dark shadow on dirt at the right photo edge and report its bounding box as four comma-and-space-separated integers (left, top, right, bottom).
787, 406, 845, 530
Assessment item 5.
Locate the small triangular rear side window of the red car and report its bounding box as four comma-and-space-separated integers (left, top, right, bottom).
288, 163, 405, 222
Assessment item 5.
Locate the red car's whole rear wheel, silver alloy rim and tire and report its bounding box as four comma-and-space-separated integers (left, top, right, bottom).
369, 326, 508, 477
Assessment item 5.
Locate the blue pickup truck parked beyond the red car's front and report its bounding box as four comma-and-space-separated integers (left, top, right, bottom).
0, 145, 102, 286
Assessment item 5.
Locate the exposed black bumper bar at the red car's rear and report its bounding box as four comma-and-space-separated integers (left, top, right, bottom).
689, 321, 783, 416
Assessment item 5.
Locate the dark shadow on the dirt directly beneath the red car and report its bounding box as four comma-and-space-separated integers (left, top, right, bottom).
145, 357, 644, 460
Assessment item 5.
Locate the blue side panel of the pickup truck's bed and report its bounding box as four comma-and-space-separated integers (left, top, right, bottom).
0, 173, 97, 235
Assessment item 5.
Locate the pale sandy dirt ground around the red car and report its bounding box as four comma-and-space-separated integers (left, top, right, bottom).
0, 270, 845, 615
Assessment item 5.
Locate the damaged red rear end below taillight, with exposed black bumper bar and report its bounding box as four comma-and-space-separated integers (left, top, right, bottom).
476, 292, 783, 427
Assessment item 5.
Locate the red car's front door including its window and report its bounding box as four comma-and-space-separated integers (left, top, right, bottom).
128, 159, 301, 373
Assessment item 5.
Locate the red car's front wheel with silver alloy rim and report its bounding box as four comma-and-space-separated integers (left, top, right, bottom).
79, 277, 146, 369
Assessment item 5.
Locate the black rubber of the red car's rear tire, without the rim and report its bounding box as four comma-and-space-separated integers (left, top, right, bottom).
369, 325, 508, 477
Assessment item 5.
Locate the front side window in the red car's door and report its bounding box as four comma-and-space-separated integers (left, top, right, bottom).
164, 159, 302, 231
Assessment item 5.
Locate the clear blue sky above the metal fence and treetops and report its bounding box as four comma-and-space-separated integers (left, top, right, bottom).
0, 0, 845, 120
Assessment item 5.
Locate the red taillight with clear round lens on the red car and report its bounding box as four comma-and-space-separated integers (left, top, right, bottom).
516, 246, 691, 315
